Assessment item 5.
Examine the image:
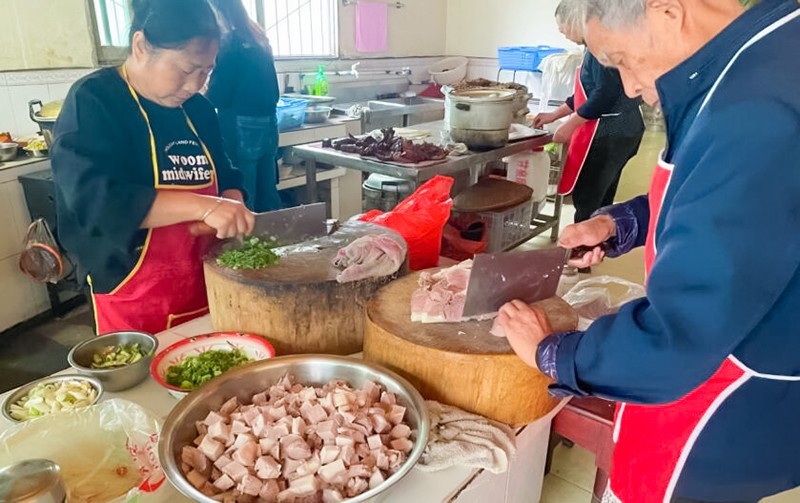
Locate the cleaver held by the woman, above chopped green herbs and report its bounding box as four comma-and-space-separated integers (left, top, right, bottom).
190, 203, 328, 245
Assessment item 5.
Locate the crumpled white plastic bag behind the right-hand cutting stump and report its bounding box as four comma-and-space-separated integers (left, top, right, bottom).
564, 276, 645, 330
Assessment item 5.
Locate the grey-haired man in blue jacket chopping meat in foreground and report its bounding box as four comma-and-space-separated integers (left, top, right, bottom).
497, 0, 800, 503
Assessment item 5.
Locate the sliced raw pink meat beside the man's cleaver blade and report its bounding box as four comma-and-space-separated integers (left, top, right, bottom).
411, 260, 472, 323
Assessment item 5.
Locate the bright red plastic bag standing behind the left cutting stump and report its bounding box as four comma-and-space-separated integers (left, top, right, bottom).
359, 175, 453, 271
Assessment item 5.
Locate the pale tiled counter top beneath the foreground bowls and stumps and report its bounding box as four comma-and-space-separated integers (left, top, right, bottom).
0, 316, 566, 503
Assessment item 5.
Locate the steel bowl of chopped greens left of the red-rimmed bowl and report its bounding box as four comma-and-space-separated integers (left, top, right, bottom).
67, 331, 158, 391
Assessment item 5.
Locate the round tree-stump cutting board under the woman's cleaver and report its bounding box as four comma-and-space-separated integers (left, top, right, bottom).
205, 222, 408, 355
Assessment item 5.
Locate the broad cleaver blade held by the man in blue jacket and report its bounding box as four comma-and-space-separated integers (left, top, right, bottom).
463, 248, 571, 318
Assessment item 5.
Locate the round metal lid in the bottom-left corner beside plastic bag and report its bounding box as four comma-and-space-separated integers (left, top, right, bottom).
0, 459, 67, 503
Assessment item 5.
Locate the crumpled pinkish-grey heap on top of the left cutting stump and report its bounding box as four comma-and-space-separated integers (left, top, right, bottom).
333, 234, 405, 283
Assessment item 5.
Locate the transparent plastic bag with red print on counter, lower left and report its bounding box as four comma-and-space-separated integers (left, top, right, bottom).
0, 399, 169, 503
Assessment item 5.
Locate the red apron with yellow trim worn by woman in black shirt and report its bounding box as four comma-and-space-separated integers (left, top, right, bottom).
89, 67, 218, 334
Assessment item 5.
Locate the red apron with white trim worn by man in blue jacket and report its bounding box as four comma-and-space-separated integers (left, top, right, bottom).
603, 156, 749, 503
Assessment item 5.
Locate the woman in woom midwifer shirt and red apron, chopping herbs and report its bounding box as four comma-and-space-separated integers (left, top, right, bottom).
52, 0, 254, 334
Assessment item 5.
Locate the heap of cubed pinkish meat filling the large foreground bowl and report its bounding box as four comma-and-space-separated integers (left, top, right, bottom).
181, 376, 414, 503
